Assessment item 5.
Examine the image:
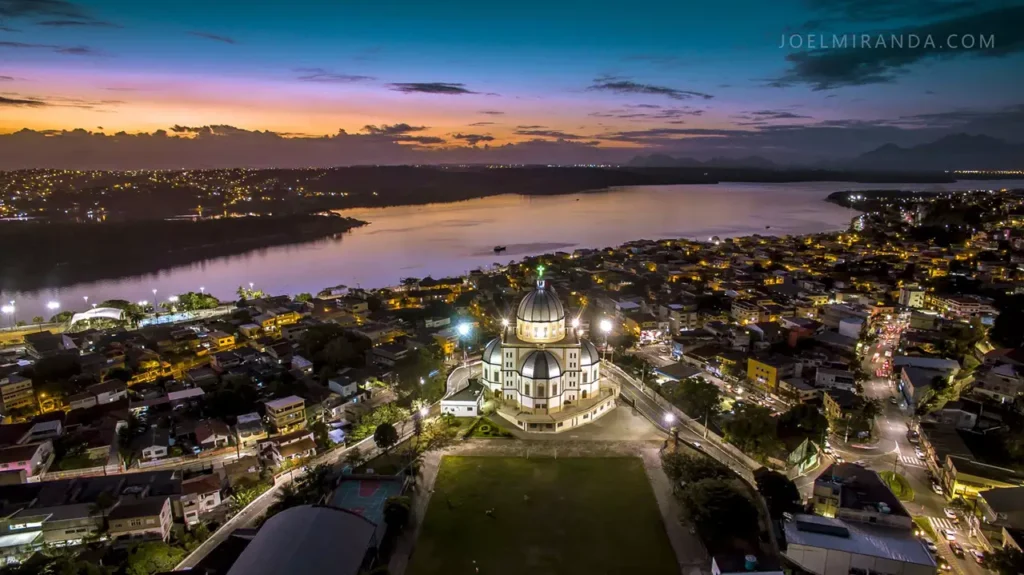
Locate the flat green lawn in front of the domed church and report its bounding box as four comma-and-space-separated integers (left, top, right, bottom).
408, 457, 679, 575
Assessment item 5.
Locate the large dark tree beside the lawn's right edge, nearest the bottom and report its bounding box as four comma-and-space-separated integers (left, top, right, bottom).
681, 479, 758, 545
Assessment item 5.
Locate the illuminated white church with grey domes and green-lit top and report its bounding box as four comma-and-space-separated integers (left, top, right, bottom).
481, 279, 615, 432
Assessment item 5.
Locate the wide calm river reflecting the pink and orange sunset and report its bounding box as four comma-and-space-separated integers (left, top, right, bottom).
0, 180, 1024, 317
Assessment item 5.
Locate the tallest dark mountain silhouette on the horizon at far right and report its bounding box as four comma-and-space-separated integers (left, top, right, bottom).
846, 134, 1024, 172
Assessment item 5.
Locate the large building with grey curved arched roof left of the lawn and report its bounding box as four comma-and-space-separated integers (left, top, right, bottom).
227, 505, 380, 575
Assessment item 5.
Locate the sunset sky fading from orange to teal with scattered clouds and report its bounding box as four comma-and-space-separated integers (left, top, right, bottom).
0, 0, 1024, 169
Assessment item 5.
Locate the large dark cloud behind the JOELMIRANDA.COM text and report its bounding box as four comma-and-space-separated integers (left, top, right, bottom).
768, 5, 1024, 90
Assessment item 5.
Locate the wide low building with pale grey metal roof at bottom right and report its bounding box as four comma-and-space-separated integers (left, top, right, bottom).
782, 514, 936, 575
